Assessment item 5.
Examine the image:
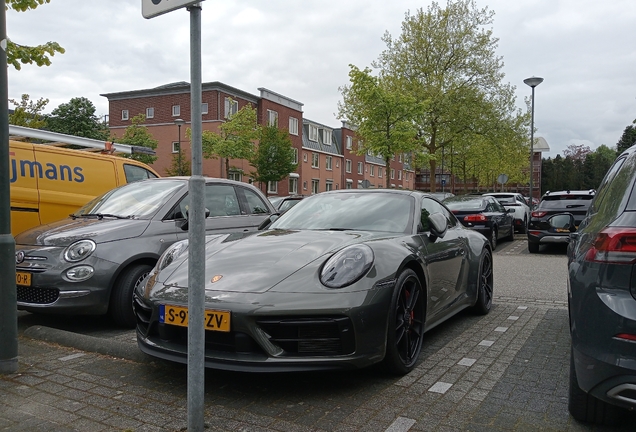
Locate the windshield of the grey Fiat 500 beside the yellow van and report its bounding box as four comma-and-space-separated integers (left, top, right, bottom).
71, 180, 183, 218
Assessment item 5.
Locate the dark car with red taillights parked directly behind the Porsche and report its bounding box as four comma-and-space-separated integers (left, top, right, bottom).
444, 195, 515, 250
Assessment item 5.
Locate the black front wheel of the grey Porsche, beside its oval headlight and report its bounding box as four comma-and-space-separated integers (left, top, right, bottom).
384, 269, 424, 375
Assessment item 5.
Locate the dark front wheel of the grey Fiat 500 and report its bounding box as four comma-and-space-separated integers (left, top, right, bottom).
109, 264, 152, 328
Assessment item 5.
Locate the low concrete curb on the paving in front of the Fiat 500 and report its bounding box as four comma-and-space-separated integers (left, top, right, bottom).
23, 326, 155, 363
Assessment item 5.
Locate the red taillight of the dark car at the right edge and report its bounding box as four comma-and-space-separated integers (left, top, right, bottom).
585, 228, 636, 264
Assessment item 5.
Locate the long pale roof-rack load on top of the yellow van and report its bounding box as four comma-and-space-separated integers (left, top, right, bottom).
9, 125, 156, 156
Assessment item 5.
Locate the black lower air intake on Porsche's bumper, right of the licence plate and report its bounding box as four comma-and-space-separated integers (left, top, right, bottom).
256, 317, 355, 356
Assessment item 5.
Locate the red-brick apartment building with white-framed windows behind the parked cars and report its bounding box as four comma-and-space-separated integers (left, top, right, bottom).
101, 82, 415, 196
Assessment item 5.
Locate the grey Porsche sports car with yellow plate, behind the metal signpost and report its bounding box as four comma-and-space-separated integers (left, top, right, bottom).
134, 189, 493, 374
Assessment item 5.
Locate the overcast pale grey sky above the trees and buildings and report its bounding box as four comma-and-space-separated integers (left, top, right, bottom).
7, 0, 636, 157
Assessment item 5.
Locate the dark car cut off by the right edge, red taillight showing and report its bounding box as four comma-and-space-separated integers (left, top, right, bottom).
568, 146, 636, 424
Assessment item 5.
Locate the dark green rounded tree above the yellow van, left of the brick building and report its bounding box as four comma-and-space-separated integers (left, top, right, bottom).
46, 97, 110, 140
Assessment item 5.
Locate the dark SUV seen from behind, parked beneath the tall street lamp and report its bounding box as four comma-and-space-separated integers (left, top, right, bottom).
528, 189, 595, 253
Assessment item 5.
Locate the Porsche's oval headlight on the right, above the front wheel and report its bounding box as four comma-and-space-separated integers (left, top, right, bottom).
320, 245, 373, 288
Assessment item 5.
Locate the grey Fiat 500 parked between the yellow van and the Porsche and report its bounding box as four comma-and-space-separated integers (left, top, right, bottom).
15, 177, 275, 327
